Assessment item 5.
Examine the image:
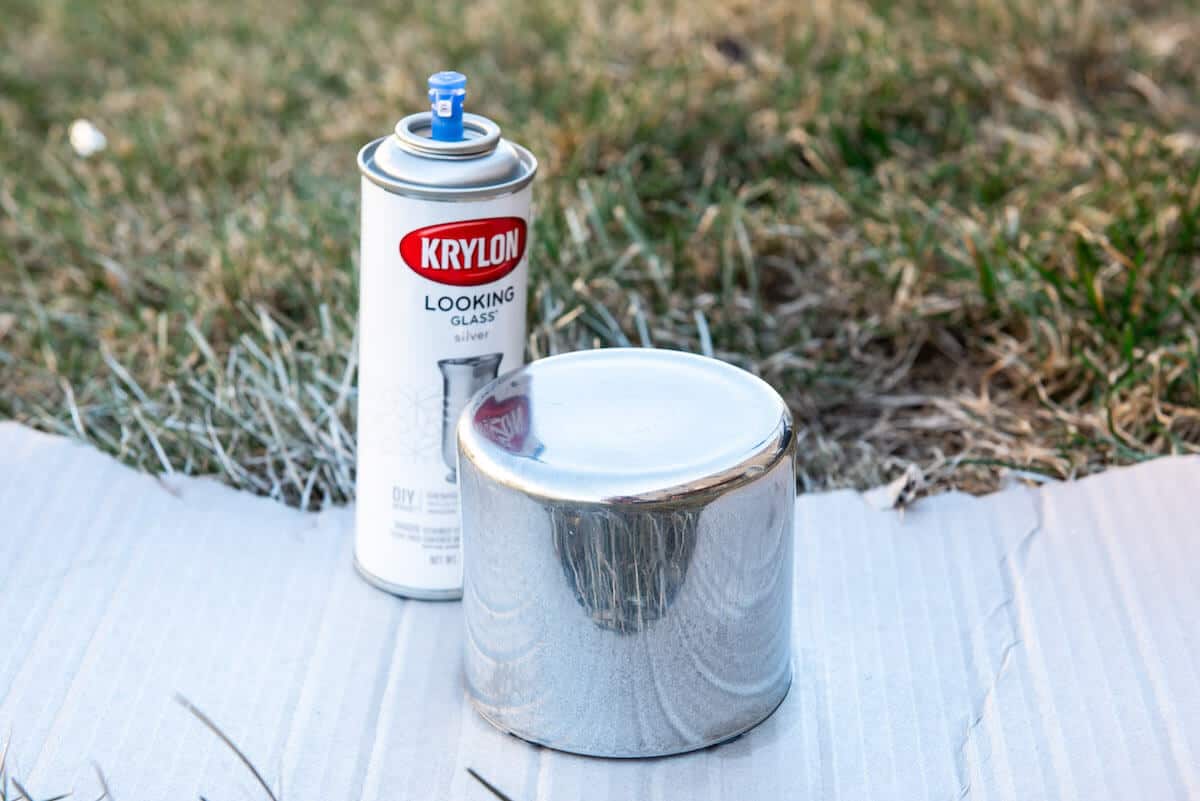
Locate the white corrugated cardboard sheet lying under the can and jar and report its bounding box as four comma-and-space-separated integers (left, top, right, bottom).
0, 423, 1200, 801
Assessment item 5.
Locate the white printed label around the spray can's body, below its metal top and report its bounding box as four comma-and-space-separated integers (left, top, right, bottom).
356, 179, 530, 592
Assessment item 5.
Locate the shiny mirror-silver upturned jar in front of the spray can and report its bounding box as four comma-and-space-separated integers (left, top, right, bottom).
458, 349, 796, 757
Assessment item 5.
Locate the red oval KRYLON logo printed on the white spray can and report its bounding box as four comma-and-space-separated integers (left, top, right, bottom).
400, 217, 527, 287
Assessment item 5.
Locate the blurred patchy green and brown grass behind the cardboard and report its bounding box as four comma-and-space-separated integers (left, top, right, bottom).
0, 0, 1200, 507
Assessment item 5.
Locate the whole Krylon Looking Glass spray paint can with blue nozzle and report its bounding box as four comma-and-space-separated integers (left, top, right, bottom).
354, 72, 538, 600
